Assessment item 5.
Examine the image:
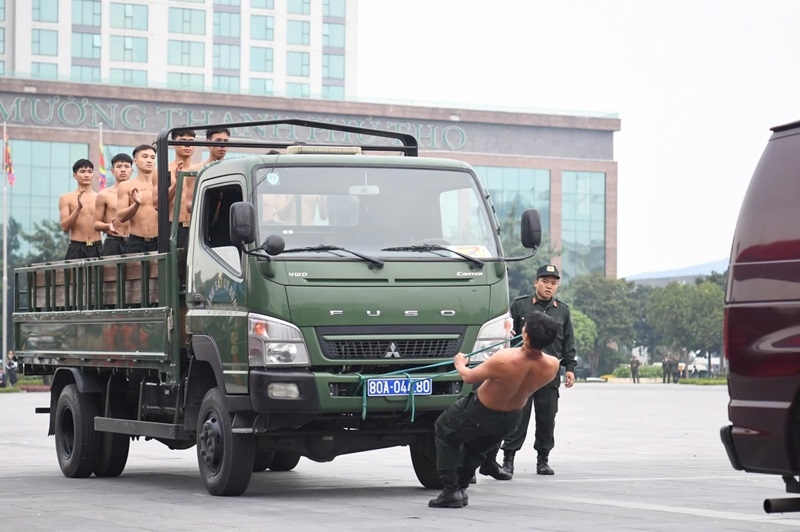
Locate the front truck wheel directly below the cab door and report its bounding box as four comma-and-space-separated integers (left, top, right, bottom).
197, 388, 256, 496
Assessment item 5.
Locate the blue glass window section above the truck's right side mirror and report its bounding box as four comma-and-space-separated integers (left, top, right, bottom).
474, 166, 550, 233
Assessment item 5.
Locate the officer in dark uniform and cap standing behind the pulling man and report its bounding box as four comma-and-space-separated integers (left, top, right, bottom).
479, 264, 577, 480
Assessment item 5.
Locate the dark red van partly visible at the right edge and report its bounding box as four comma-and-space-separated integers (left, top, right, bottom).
721, 121, 800, 511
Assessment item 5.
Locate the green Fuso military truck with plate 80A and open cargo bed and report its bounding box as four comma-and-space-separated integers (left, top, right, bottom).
14, 119, 541, 495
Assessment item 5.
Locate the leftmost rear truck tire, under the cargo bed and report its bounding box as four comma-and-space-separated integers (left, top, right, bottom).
55, 384, 100, 478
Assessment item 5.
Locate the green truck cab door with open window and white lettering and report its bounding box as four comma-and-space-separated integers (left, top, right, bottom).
186, 175, 248, 394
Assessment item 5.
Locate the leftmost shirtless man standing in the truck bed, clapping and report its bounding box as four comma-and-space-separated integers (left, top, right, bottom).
58, 159, 103, 260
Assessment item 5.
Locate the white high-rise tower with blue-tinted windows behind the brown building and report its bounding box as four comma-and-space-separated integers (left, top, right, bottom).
0, 0, 358, 99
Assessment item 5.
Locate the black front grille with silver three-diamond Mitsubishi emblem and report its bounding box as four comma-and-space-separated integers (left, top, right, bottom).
322, 339, 461, 360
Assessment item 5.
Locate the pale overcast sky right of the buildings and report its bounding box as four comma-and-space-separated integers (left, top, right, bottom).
358, 0, 800, 277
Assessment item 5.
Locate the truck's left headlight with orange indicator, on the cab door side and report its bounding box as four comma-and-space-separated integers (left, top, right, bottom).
247, 314, 310, 367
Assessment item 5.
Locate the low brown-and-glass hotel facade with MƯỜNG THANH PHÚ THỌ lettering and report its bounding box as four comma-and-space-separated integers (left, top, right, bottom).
0, 77, 620, 280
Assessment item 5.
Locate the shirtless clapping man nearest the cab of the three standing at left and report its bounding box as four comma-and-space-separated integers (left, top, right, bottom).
113, 144, 158, 253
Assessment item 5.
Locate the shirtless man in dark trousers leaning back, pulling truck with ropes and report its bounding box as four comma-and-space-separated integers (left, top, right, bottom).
428, 312, 559, 508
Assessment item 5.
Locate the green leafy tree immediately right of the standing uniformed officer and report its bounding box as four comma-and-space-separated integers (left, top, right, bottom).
567, 273, 634, 375
